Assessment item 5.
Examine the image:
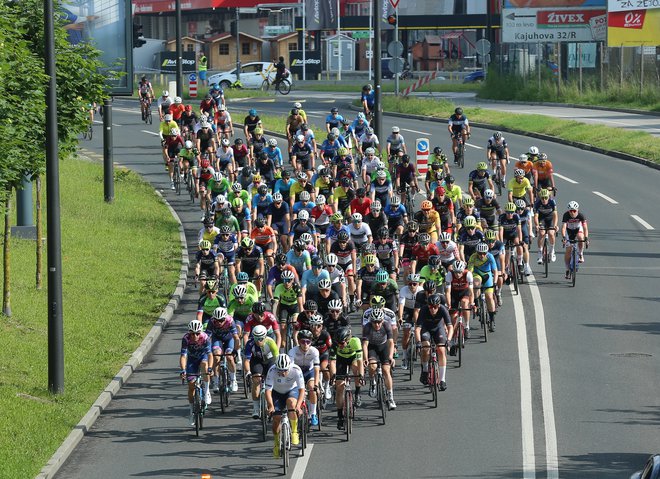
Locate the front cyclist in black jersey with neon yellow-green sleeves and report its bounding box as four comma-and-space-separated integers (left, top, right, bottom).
326, 327, 364, 430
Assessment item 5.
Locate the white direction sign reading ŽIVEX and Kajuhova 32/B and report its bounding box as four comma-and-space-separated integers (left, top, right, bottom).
502, 7, 605, 43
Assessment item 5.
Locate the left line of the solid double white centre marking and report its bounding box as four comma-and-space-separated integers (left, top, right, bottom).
510, 285, 536, 479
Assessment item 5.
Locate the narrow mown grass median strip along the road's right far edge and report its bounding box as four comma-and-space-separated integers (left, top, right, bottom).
366, 97, 660, 163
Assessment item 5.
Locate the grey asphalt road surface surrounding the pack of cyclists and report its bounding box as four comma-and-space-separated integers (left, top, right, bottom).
57, 92, 660, 479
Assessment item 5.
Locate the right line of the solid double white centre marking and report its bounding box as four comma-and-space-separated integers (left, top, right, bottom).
527, 275, 559, 479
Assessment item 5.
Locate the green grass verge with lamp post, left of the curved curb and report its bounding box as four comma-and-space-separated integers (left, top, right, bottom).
0, 160, 181, 478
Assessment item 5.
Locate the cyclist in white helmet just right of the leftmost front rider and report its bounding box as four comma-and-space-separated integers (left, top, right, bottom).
206, 307, 240, 393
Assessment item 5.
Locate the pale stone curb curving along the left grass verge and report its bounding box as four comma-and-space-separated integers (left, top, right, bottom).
36, 168, 190, 479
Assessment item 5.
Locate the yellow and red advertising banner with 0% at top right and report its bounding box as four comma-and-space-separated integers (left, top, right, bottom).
607, 7, 660, 47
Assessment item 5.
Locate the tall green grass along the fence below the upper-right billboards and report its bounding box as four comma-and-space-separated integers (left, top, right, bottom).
477, 70, 660, 111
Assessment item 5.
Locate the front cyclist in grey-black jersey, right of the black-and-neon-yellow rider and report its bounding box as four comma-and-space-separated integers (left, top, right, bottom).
362, 309, 396, 410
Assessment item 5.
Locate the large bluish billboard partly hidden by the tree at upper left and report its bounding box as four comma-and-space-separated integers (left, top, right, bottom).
60, 0, 133, 95
